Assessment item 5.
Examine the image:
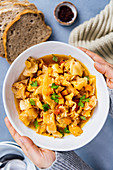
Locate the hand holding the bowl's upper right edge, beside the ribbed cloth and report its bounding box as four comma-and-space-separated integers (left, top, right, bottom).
78, 47, 113, 89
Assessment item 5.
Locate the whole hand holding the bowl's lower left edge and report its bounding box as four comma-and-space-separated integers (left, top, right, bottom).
5, 117, 56, 168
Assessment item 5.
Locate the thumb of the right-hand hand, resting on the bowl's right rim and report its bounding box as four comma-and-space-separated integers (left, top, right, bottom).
94, 62, 113, 79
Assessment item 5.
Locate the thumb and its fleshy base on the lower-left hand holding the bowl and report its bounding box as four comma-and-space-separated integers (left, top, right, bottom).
20, 136, 56, 168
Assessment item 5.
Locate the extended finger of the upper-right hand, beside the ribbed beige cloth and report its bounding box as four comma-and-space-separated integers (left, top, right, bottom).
77, 47, 107, 63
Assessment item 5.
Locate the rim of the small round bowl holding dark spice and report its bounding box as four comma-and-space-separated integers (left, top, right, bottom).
54, 1, 78, 26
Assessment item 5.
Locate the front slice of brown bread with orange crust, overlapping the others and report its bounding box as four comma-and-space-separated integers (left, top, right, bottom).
3, 10, 52, 64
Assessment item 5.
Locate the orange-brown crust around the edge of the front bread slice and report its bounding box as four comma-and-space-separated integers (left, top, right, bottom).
3, 9, 52, 64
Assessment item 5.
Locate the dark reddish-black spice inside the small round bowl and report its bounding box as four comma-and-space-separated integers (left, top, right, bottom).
58, 5, 74, 22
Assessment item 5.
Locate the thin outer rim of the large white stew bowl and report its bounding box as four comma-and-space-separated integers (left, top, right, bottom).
2, 41, 110, 151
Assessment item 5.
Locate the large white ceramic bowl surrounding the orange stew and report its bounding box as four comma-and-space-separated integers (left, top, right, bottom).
3, 41, 109, 151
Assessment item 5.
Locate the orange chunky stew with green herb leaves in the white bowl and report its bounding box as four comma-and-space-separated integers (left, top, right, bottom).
12, 54, 97, 138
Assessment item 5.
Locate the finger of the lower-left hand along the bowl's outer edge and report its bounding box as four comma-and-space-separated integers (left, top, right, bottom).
5, 117, 28, 156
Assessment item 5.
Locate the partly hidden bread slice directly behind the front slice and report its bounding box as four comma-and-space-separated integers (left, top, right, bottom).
0, 3, 37, 57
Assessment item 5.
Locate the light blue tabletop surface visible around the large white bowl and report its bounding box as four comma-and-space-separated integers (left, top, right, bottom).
0, 0, 113, 170
